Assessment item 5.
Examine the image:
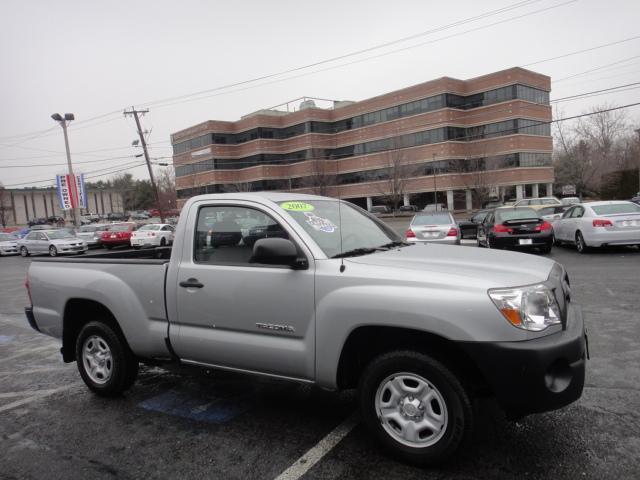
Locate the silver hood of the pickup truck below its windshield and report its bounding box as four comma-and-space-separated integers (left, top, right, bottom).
345, 244, 555, 288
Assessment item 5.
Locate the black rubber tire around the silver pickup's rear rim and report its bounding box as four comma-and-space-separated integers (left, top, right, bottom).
76, 321, 138, 397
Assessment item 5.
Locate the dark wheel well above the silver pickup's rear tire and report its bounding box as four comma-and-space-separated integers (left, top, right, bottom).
62, 298, 124, 362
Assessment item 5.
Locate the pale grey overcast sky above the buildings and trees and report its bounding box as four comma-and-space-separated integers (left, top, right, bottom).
0, 0, 640, 186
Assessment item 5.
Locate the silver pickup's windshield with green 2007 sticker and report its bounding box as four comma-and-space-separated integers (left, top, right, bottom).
280, 200, 402, 257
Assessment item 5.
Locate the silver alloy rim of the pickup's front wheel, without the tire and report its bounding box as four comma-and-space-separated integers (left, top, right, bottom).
375, 372, 449, 448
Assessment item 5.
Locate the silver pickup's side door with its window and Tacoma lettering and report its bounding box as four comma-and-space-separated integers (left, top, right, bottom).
171, 201, 315, 380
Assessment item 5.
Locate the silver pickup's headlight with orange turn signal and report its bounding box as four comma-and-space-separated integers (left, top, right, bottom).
488, 284, 561, 332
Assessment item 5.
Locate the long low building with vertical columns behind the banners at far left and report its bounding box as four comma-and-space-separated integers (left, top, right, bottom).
0, 187, 124, 225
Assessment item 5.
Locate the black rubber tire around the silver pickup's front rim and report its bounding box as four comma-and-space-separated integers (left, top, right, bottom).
358, 351, 473, 465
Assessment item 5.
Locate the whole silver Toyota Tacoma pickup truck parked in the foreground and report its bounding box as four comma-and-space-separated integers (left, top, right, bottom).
26, 192, 587, 463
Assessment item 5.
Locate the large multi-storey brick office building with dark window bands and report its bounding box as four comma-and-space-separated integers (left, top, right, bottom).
171, 68, 554, 210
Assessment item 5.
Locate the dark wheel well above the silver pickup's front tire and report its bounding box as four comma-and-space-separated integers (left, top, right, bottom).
337, 326, 491, 395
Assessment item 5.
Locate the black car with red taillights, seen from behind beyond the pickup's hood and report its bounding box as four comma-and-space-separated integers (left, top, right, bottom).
478, 207, 553, 253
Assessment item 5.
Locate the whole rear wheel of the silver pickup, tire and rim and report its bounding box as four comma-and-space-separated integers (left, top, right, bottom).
76, 321, 138, 397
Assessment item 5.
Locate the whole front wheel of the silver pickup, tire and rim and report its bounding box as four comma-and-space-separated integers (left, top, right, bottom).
358, 351, 473, 465
